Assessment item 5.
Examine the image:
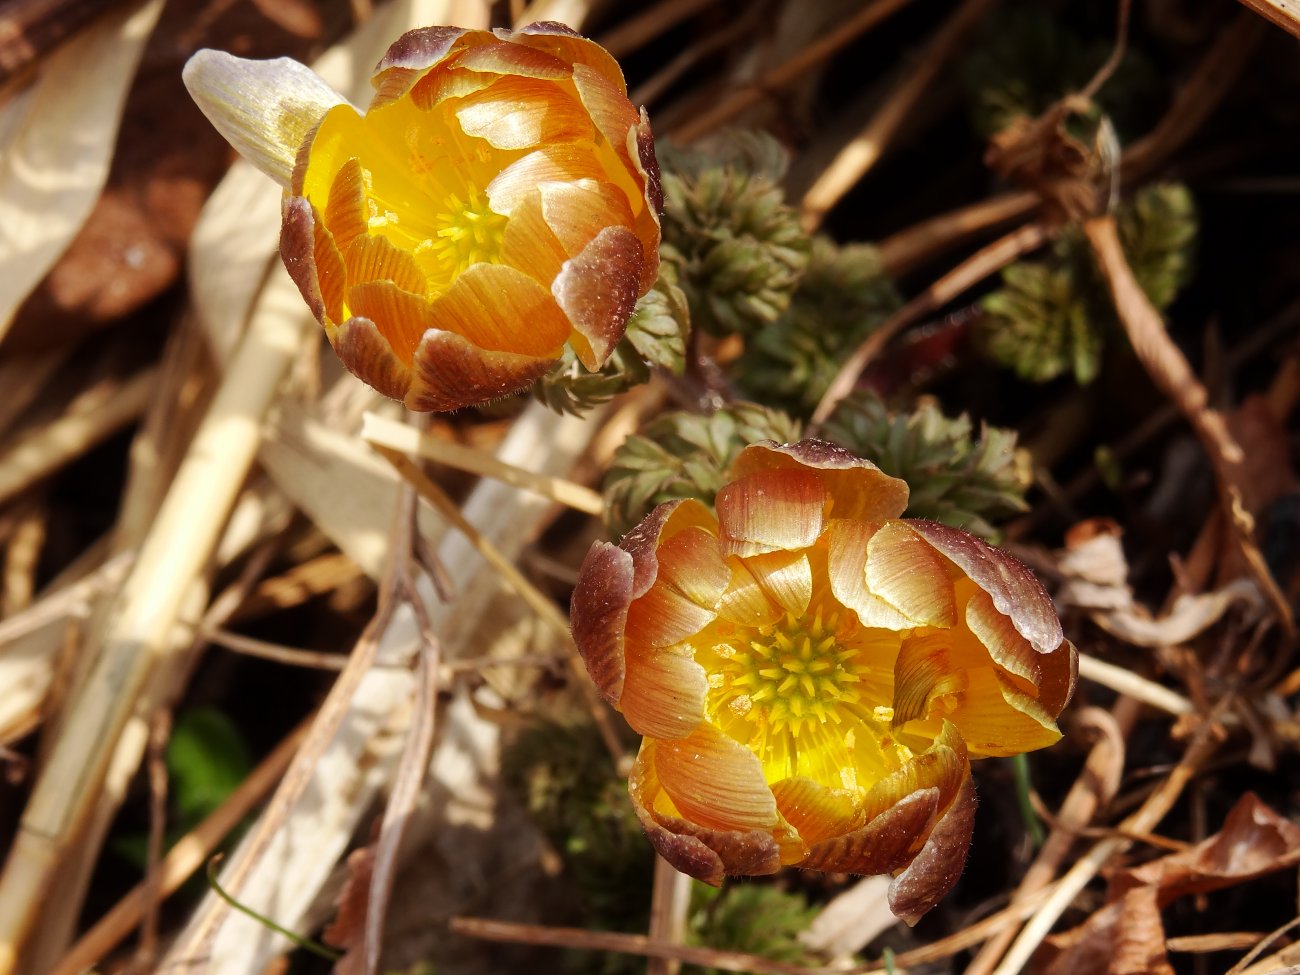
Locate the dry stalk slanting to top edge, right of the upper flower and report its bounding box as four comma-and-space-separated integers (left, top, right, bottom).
800, 0, 995, 234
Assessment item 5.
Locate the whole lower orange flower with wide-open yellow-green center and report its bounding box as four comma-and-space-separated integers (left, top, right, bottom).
572, 439, 1078, 922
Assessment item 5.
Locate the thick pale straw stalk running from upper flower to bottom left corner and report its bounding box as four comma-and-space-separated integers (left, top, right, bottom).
0, 274, 304, 975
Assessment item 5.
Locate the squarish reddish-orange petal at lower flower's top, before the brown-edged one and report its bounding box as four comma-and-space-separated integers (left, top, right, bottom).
715, 469, 826, 555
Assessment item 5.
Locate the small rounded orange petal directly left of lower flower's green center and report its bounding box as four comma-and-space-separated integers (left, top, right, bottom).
619, 650, 709, 738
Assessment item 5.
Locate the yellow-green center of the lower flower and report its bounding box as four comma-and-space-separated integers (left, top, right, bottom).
719, 611, 863, 738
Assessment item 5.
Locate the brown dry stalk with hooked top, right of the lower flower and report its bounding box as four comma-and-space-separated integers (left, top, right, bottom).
965, 707, 1125, 975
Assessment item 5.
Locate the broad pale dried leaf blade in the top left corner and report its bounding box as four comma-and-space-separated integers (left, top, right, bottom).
0, 0, 163, 338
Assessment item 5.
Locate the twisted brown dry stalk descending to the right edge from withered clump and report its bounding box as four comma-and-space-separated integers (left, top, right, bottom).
1083, 215, 1295, 633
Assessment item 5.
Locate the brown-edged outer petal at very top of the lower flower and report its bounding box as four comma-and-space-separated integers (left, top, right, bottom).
731, 438, 907, 521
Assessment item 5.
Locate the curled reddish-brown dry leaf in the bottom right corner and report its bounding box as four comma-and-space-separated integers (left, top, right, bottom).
1045, 793, 1300, 975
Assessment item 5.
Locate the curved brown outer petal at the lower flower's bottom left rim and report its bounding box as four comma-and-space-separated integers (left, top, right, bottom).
628, 740, 781, 887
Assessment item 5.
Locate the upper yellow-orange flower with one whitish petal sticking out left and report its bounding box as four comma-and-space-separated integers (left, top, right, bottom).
185, 23, 662, 410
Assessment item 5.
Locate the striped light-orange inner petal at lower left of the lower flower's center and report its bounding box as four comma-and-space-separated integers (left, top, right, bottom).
655, 724, 777, 832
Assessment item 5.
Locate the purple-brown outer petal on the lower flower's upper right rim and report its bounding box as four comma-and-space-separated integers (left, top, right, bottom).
907, 519, 1065, 654
